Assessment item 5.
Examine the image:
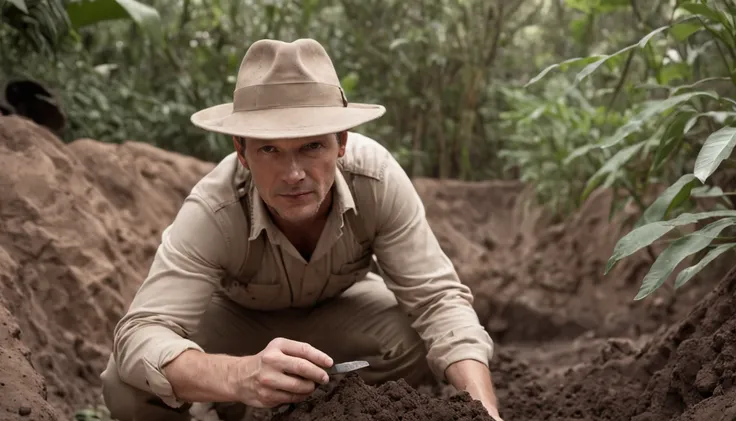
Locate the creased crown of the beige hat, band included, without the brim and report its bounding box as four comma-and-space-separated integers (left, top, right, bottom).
233, 39, 348, 113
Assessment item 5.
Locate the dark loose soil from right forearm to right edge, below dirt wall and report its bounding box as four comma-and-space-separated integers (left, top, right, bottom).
492, 270, 736, 421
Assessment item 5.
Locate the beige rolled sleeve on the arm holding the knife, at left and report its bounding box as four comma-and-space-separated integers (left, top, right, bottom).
113, 194, 227, 407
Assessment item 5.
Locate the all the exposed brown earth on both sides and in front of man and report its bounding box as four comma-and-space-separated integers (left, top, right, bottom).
0, 113, 736, 421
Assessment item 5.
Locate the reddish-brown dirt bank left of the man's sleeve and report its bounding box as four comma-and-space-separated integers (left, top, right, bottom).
0, 117, 211, 418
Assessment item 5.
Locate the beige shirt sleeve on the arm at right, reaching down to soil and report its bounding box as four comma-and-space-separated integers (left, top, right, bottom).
373, 159, 493, 381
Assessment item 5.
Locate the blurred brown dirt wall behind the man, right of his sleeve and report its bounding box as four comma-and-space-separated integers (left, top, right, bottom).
416, 179, 723, 344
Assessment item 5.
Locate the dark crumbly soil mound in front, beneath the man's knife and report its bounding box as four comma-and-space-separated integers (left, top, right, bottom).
271, 373, 493, 421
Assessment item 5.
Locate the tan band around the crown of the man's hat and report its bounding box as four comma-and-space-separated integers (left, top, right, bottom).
233, 82, 348, 112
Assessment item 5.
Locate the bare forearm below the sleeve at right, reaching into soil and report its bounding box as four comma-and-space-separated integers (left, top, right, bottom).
445, 360, 503, 421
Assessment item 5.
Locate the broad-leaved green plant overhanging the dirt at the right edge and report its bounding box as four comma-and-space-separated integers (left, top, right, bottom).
527, 0, 736, 300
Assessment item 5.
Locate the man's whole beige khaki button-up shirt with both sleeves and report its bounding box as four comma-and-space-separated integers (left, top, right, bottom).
113, 133, 493, 407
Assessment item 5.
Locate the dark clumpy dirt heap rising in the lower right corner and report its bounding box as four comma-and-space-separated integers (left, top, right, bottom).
633, 269, 736, 421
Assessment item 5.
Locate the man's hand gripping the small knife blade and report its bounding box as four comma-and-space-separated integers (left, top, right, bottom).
229, 338, 333, 408
